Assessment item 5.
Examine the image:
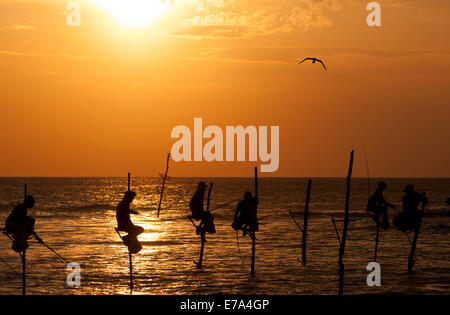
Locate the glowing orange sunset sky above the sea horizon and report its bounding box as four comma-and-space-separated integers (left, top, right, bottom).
0, 0, 450, 177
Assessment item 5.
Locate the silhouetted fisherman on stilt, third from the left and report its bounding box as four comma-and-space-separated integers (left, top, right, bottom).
188, 182, 216, 234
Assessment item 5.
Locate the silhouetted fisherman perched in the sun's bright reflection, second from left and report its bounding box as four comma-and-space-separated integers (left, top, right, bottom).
116, 190, 144, 254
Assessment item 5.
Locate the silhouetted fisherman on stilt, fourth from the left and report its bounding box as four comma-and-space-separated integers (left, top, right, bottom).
231, 191, 259, 236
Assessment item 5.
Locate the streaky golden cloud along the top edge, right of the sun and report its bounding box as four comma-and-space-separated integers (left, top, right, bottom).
173, 0, 346, 39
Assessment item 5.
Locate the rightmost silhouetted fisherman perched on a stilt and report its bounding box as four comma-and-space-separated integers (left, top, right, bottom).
392, 185, 428, 232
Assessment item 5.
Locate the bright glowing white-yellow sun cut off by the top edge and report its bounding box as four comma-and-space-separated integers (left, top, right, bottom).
95, 0, 170, 28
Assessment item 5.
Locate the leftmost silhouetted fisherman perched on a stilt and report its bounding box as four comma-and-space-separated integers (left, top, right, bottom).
5, 196, 43, 252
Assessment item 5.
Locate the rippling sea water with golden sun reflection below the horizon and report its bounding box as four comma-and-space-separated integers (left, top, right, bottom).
0, 178, 450, 294
